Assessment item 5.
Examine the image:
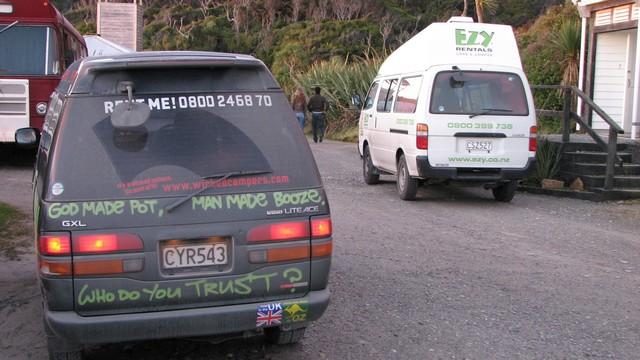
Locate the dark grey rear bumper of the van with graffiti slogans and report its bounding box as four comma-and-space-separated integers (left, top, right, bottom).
45, 289, 330, 344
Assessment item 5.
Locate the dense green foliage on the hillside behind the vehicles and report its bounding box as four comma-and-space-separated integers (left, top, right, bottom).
53, 0, 575, 136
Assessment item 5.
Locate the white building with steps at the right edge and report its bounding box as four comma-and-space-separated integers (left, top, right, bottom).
573, 0, 640, 139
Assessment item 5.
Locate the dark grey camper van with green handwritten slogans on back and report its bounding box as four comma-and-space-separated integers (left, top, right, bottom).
16, 52, 332, 359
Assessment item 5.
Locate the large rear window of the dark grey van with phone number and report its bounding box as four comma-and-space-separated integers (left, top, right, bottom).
45, 91, 320, 201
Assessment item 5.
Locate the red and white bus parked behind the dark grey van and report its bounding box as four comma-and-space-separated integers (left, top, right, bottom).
0, 0, 87, 143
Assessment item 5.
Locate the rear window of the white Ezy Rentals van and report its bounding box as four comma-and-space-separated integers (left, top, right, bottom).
430, 71, 529, 116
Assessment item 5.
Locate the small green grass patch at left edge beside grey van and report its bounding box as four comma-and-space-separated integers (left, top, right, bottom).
0, 202, 29, 260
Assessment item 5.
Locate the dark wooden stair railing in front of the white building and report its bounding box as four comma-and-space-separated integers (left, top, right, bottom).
531, 85, 624, 190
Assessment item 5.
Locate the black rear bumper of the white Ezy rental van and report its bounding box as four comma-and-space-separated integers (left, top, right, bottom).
416, 156, 536, 182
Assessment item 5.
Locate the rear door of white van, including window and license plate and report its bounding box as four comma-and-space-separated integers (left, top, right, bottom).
427, 70, 535, 168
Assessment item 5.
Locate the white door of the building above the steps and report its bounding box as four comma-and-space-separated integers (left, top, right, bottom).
592, 30, 637, 131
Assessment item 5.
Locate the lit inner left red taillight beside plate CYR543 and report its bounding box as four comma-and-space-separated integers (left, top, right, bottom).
73, 234, 144, 254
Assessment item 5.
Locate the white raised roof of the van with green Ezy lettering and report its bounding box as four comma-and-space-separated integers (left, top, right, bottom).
378, 21, 522, 76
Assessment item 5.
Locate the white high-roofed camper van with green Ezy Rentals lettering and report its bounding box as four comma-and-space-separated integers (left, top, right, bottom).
359, 17, 537, 201
